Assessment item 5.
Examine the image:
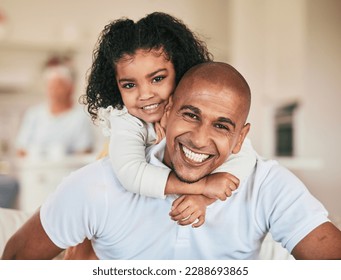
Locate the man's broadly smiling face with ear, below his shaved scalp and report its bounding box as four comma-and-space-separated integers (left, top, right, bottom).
164, 62, 249, 183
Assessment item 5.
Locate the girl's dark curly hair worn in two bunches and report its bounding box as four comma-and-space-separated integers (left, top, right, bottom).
81, 12, 213, 121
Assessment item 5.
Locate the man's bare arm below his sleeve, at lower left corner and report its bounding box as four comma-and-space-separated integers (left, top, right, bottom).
2, 211, 63, 260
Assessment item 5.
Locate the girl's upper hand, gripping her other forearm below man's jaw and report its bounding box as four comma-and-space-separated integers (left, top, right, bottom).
202, 172, 239, 200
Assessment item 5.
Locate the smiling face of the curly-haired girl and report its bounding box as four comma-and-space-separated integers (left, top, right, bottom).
116, 49, 175, 123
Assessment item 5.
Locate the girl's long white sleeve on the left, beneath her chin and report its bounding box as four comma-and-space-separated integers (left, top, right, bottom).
102, 108, 170, 198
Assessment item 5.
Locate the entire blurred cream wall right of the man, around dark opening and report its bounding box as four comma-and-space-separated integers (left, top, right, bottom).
230, 0, 341, 219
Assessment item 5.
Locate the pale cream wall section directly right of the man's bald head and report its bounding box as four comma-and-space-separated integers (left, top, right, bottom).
230, 0, 306, 157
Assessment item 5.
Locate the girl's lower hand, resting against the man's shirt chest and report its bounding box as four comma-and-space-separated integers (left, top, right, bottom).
169, 194, 215, 227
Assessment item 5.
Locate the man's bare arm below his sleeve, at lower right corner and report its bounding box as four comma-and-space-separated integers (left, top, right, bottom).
292, 222, 341, 260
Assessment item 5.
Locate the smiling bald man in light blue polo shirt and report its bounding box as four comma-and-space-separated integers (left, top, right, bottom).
3, 62, 341, 259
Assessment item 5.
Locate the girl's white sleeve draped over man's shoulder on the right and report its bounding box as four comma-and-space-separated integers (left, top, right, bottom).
214, 138, 257, 184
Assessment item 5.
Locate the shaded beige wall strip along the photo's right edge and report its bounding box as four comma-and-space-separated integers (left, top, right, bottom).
298, 0, 341, 219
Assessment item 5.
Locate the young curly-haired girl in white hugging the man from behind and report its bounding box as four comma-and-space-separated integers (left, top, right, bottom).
79, 13, 255, 227
